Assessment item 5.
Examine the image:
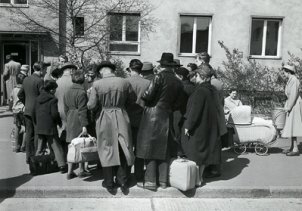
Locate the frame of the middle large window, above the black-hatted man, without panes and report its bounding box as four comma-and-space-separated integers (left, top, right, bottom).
178, 13, 214, 57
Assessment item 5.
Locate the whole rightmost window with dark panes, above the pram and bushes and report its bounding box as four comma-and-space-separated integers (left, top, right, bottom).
250, 18, 282, 58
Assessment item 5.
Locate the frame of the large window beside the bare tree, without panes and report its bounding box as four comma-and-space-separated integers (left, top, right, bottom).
108, 12, 141, 55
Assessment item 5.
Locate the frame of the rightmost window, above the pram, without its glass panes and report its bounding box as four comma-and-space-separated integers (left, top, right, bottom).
249, 16, 284, 60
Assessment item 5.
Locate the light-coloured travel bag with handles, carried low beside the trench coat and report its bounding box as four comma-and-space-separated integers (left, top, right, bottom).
67, 135, 99, 163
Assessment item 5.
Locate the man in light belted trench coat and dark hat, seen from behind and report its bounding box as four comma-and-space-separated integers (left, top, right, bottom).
87, 61, 136, 193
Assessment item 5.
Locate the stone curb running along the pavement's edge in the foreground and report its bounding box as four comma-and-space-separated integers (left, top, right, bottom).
0, 186, 302, 198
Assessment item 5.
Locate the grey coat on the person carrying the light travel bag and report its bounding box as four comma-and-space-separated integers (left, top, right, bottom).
64, 83, 88, 143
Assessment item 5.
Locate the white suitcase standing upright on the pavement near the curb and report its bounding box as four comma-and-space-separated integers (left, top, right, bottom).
169, 158, 200, 191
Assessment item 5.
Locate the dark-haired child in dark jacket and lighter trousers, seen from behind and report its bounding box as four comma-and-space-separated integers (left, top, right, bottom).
34, 80, 67, 173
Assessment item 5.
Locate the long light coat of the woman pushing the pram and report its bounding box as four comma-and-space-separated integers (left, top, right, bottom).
282, 75, 302, 138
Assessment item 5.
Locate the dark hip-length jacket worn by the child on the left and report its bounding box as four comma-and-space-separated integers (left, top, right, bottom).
34, 90, 62, 135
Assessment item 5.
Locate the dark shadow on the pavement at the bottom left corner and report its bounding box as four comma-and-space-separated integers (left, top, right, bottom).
0, 174, 33, 203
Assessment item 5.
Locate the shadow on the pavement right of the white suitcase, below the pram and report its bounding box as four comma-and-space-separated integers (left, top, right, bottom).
205, 149, 250, 183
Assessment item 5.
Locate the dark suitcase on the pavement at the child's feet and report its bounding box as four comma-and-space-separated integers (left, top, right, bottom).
29, 155, 59, 175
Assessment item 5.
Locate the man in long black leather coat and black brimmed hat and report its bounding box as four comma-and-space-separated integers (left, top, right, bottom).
136, 53, 184, 190
